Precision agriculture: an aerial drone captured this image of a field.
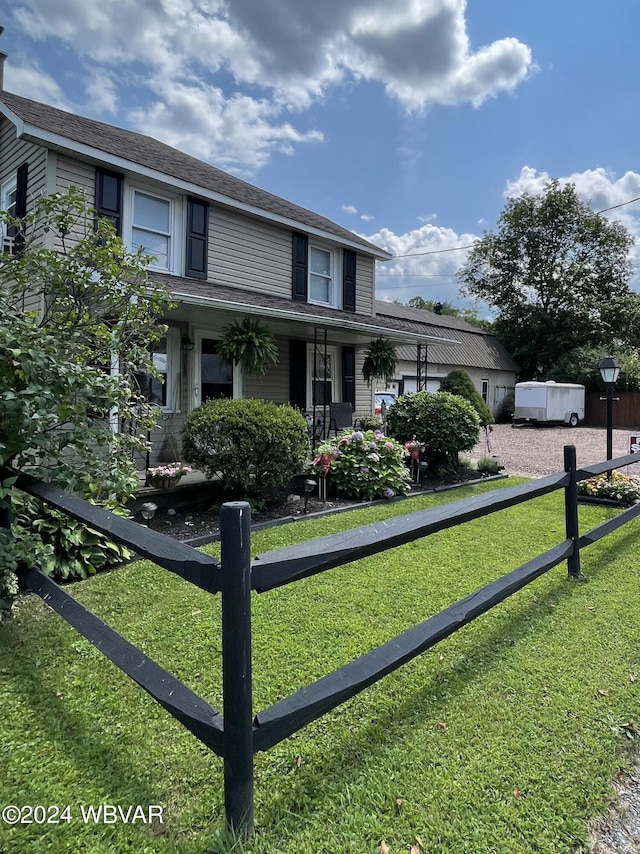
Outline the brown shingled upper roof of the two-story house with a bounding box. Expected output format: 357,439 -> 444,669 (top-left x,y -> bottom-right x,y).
0,92 -> 390,259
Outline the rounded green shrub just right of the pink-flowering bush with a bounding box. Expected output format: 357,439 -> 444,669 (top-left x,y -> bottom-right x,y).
387,391 -> 480,477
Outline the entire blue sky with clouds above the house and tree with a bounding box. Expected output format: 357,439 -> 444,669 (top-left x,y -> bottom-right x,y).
0,0 -> 640,314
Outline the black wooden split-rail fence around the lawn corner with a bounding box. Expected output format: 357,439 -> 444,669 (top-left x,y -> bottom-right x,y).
0,446 -> 640,835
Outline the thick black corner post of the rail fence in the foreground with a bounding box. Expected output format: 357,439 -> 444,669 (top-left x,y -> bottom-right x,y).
220,501 -> 253,838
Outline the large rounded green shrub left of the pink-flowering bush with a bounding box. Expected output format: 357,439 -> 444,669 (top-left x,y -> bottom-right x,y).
182,398 -> 310,498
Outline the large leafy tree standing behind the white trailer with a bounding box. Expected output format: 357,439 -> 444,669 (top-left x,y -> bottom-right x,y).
459,181 -> 637,379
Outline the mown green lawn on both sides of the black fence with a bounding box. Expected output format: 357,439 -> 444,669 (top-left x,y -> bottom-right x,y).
0,478 -> 640,854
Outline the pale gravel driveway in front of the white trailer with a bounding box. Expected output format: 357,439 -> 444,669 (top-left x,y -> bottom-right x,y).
463,424 -> 640,477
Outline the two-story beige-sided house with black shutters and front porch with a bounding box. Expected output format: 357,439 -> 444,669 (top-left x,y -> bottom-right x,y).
0,75 -> 458,459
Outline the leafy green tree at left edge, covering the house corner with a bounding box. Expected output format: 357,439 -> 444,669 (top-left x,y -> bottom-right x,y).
0,189 -> 170,596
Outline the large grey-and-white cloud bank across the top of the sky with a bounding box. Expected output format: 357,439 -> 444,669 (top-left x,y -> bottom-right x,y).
11,0 -> 533,168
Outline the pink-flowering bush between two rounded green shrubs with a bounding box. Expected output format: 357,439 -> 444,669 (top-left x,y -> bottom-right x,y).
312,429 -> 411,500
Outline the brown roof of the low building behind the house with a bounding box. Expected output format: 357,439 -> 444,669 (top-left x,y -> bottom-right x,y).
376,300 -> 520,372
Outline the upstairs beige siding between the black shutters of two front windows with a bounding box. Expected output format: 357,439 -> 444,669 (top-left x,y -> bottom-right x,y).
208,205 -> 291,297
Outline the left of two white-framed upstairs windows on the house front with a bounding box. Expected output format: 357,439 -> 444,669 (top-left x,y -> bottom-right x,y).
131,189 -> 177,270
